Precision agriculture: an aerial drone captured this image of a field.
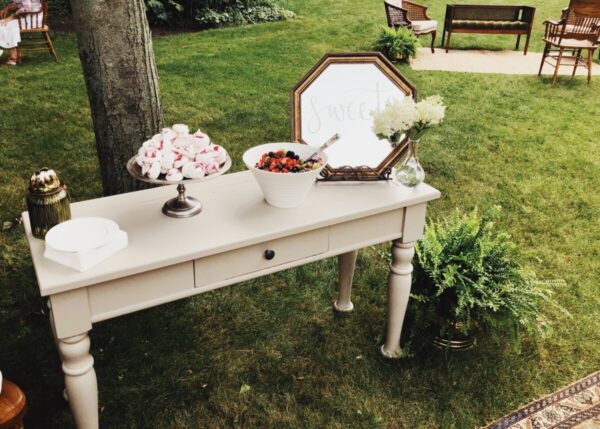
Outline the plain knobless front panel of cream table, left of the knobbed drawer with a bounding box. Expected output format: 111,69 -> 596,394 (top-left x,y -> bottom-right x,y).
88,261 -> 194,322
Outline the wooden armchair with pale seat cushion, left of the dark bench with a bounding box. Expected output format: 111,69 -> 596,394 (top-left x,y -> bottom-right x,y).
383,0 -> 437,53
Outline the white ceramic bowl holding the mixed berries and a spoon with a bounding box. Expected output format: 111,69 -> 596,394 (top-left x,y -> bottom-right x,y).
244,143 -> 327,209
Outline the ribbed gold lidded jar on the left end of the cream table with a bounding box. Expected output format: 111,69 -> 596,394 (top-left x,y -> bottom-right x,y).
27,167 -> 71,239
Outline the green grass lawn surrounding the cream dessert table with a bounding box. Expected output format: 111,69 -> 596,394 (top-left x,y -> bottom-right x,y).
0,0 -> 600,428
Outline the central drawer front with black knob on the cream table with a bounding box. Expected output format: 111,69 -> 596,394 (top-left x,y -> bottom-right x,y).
194,228 -> 329,287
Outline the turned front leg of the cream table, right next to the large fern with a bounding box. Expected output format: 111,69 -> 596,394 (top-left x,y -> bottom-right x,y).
381,240 -> 415,359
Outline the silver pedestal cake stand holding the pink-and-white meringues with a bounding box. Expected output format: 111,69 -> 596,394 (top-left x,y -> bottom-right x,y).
127,154 -> 231,218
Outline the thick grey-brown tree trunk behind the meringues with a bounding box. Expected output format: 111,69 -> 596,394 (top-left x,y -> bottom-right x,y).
71,0 -> 163,195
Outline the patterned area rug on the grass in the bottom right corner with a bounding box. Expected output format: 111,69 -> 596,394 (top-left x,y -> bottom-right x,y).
484,371 -> 600,429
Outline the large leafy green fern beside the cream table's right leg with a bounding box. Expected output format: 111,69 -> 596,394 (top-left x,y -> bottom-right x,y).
400,207 -> 565,353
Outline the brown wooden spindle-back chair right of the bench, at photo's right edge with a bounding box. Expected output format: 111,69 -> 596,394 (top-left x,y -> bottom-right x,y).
538,0 -> 600,84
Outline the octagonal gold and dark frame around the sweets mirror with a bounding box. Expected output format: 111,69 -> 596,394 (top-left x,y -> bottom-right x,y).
292,52 -> 417,181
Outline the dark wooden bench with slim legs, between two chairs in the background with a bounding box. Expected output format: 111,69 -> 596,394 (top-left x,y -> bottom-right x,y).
442,4 -> 535,55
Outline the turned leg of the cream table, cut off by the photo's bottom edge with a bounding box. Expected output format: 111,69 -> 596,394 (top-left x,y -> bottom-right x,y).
58,332 -> 99,429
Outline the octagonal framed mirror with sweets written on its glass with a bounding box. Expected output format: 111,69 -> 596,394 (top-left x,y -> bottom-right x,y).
292,52 -> 416,180
